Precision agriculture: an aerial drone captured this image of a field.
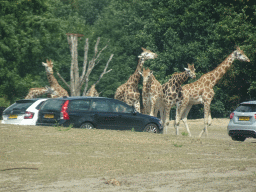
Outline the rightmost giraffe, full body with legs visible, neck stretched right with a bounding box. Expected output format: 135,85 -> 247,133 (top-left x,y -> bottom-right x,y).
174,47 -> 250,138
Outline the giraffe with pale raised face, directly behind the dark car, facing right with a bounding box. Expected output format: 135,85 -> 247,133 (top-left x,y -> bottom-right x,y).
114,47 -> 157,112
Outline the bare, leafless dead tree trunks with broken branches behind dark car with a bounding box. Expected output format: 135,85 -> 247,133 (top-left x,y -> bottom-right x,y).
58,33 -> 114,96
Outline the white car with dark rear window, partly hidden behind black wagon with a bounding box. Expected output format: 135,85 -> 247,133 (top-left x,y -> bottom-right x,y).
2,98 -> 47,125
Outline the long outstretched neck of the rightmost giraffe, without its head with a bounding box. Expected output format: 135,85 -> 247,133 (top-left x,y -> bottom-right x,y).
200,52 -> 235,87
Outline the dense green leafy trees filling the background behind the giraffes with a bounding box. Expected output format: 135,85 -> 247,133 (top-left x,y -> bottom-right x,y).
0,0 -> 256,118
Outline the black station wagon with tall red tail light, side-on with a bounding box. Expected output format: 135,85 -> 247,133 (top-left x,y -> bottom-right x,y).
36,97 -> 163,133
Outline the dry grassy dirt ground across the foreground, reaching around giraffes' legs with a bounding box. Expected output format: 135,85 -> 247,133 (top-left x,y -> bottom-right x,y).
0,119 -> 256,192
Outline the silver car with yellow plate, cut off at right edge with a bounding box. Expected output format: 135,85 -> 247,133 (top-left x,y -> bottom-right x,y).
228,101 -> 256,141
